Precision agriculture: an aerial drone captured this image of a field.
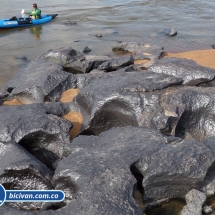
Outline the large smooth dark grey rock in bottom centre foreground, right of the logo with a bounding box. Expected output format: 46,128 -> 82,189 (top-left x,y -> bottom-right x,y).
49,127 -> 165,215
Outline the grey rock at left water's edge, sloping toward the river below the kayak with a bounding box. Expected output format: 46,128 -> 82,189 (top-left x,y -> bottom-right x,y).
4,60 -> 76,104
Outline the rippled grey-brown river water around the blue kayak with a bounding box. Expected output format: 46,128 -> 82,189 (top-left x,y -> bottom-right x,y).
0,0 -> 215,85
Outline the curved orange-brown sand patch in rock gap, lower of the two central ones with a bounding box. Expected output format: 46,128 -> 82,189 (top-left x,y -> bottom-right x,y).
63,111 -> 83,138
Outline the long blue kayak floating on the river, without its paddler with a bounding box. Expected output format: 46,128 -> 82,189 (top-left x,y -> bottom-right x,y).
0,14 -> 58,28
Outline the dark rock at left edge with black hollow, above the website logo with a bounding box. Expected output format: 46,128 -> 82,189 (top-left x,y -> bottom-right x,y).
0,104 -> 72,169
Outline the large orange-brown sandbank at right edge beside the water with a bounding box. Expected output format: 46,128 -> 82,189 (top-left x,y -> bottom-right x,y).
163,49 -> 215,69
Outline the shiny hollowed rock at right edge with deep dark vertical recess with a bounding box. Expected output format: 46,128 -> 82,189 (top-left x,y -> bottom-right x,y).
160,87 -> 215,141
